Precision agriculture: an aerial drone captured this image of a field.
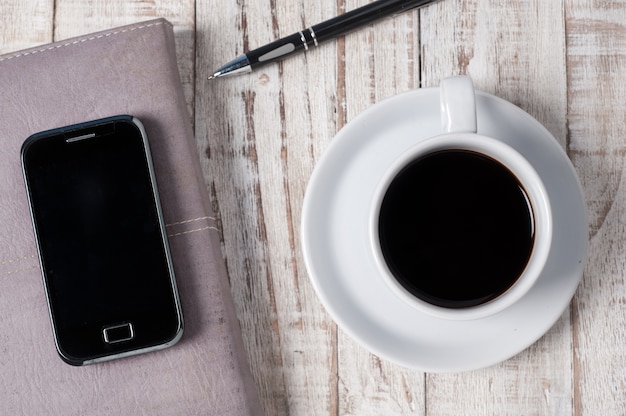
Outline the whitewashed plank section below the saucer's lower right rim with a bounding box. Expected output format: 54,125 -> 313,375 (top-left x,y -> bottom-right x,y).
426,314 -> 572,416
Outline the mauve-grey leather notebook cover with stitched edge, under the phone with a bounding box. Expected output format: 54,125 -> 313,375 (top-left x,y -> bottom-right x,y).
0,19 -> 262,416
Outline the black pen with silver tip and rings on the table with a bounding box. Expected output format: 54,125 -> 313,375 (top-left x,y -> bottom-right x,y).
209,0 -> 436,79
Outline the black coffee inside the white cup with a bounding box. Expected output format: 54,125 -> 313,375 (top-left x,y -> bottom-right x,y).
378,150 -> 534,308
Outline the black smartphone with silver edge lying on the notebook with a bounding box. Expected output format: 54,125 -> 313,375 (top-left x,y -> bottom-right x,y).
21,115 -> 183,365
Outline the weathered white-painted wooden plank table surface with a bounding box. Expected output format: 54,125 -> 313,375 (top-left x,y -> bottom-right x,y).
0,0 -> 626,416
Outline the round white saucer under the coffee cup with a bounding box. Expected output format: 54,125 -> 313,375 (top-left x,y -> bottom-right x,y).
302,88 -> 588,372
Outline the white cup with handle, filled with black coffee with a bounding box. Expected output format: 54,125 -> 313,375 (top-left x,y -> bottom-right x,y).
369,77 -> 553,320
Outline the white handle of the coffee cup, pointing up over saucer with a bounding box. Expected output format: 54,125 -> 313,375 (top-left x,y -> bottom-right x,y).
439,76 -> 477,133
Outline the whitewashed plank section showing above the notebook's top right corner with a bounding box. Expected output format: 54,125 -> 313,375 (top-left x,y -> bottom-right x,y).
54,0 -> 195,117
